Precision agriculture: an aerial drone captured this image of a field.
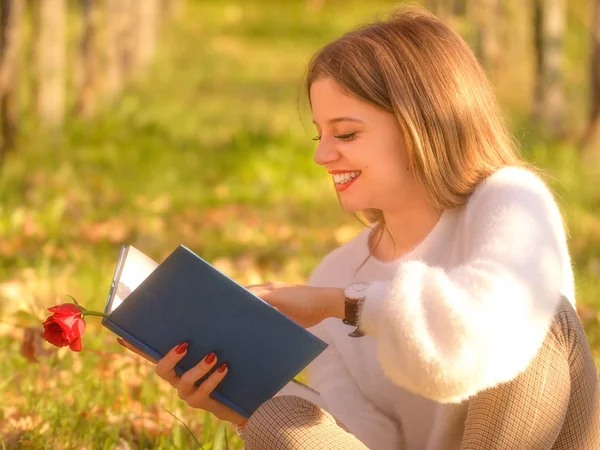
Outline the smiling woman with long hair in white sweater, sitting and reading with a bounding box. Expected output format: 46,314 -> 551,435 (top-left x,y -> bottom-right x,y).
118,8 -> 600,449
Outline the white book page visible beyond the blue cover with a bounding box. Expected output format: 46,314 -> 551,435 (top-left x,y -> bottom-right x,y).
108,245 -> 158,313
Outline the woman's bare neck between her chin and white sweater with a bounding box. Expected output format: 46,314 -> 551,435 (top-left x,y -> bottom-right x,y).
371,204 -> 441,261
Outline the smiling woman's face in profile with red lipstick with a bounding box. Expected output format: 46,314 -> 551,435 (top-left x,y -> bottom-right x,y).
310,78 -> 423,213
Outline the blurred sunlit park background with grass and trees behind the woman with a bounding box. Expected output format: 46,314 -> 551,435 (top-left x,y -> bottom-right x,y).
0,0 -> 600,449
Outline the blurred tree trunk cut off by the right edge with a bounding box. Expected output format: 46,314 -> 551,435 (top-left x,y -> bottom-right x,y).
582,0 -> 600,152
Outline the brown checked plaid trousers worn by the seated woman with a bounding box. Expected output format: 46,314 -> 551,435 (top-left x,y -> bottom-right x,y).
244,298 -> 600,450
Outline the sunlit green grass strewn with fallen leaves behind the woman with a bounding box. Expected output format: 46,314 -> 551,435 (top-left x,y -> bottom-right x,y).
0,0 -> 600,449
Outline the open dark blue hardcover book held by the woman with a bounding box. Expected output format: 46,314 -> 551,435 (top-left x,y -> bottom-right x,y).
102,245 -> 327,417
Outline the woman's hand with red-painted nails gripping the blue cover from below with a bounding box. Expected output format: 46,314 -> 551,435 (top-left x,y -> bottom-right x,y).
117,338 -> 247,426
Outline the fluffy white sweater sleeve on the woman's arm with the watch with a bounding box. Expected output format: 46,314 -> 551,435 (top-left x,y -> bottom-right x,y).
360,169 -> 574,403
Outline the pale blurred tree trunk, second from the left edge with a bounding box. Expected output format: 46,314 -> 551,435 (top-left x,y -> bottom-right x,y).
34,0 -> 67,126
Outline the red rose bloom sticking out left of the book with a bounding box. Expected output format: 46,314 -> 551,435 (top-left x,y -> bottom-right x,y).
43,303 -> 85,352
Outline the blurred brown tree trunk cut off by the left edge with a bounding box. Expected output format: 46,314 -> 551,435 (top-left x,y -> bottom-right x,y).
0,0 -> 24,158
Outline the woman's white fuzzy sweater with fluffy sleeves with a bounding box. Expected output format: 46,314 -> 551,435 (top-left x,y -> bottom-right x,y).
282,167 -> 575,450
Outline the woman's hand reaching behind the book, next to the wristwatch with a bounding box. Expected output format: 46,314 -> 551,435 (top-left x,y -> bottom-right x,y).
246,281 -> 344,328
